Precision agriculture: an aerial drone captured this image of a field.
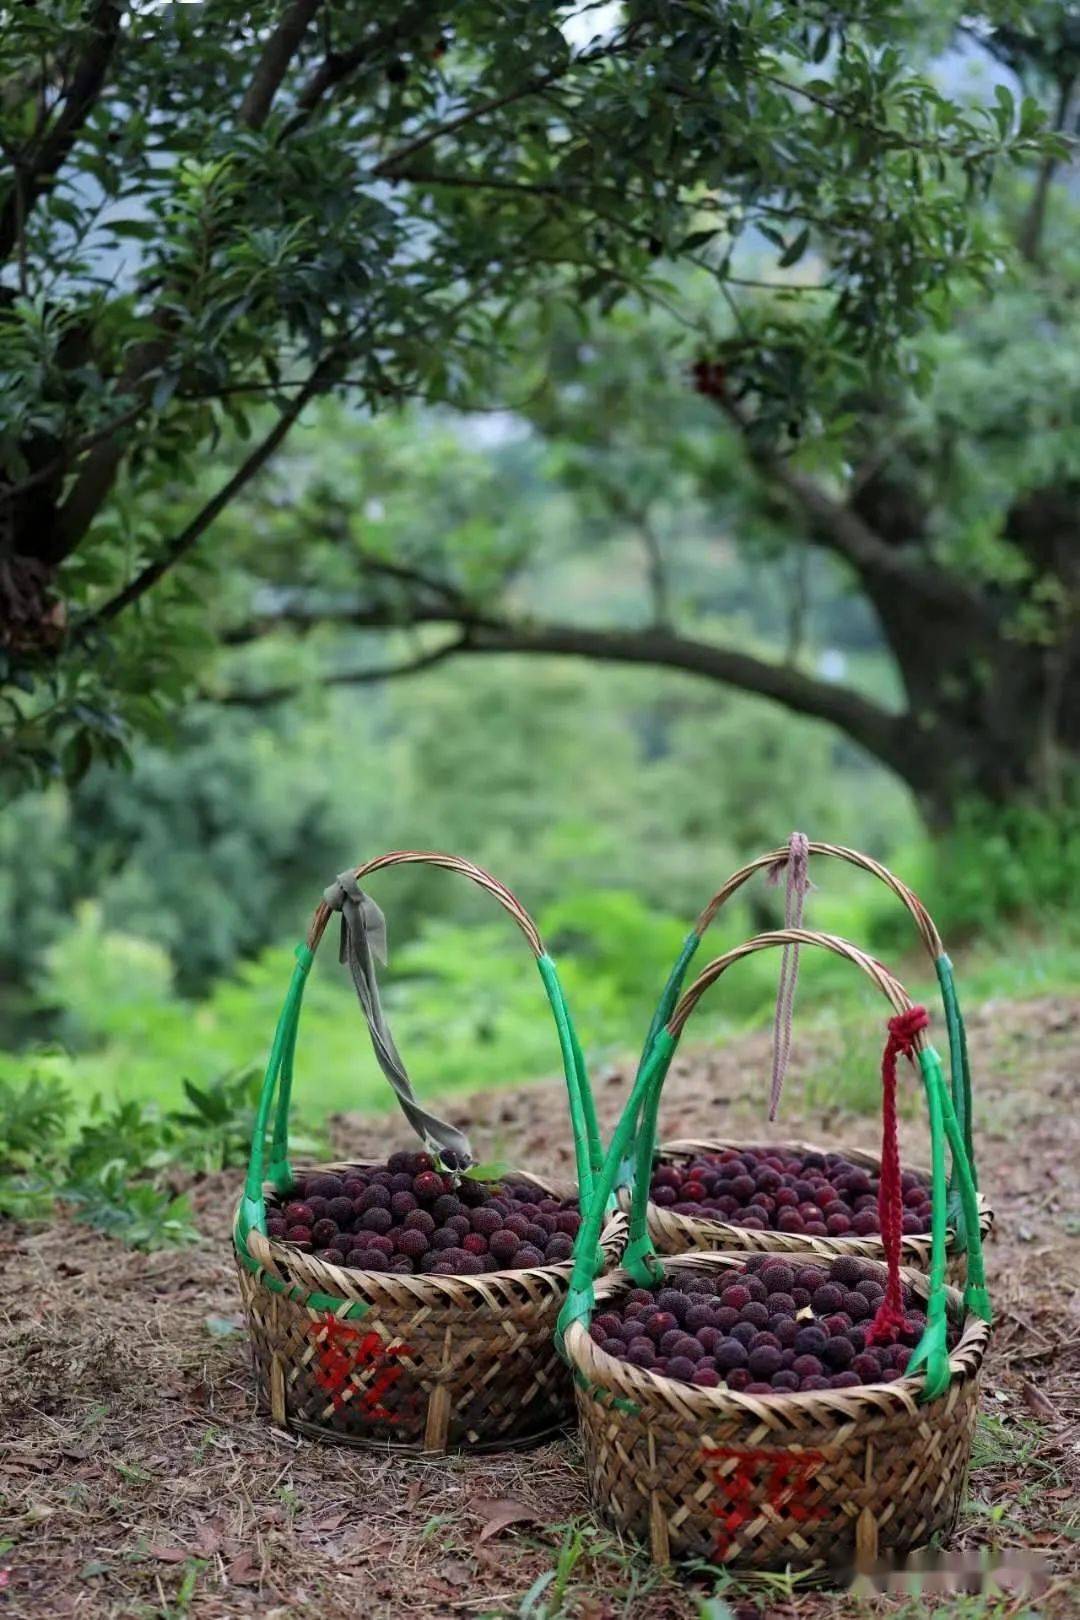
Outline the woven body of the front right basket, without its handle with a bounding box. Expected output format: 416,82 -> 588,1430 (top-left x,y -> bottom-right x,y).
565,1254 -> 989,1571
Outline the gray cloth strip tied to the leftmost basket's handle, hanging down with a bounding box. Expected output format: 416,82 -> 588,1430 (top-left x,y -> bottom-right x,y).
322,872 -> 474,1170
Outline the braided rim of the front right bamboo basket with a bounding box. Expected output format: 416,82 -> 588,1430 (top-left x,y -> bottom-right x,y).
565,1249 -> 991,1439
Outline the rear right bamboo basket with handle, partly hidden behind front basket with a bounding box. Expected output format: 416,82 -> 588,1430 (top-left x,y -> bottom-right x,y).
619,842 -> 994,1285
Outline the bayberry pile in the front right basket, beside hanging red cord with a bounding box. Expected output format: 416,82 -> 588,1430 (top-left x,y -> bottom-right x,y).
589,1254 -> 945,1395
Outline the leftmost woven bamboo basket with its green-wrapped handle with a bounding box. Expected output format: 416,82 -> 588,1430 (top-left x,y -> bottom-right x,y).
233,851 -> 625,1452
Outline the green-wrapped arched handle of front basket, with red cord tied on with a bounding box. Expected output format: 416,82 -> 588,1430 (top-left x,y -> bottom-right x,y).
559,928 -> 989,1396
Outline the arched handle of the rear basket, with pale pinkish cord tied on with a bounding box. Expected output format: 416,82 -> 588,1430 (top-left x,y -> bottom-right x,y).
641,842 -> 978,1224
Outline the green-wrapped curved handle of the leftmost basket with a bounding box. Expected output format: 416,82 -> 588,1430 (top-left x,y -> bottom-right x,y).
240,849 -> 602,1236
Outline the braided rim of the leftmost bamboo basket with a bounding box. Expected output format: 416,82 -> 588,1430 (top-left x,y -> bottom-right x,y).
232,1158 -> 627,1306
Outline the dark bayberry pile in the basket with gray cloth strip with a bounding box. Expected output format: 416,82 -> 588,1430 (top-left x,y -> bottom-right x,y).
266,1153 -> 581,1277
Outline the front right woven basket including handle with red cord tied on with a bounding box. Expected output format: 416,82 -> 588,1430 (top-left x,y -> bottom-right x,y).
559,928 -> 989,1573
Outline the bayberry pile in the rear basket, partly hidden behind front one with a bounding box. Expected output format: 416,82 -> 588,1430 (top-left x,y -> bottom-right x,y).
649,1147 -> 929,1238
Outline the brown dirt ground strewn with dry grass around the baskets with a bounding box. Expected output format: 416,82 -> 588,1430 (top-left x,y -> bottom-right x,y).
0,1000 -> 1080,1620
